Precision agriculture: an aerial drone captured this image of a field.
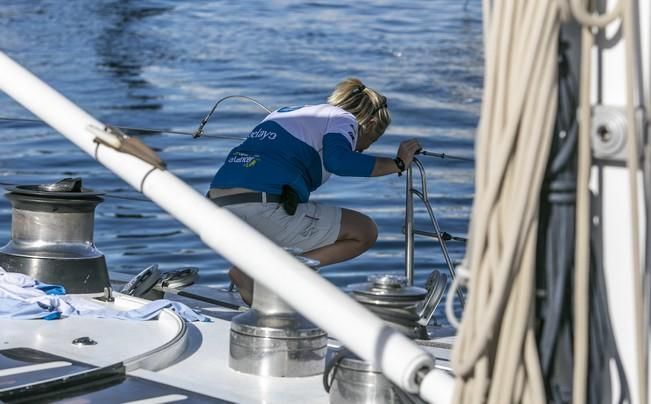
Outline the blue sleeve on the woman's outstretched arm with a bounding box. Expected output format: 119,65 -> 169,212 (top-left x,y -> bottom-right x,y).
323,133 -> 375,177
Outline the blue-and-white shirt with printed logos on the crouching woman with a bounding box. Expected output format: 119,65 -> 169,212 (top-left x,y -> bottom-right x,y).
210,104 -> 375,202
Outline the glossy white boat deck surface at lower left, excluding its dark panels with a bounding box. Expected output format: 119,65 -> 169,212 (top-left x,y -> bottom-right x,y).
0,294 -> 452,404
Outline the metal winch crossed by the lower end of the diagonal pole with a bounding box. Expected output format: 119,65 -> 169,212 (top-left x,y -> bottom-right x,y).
324,271 -> 447,404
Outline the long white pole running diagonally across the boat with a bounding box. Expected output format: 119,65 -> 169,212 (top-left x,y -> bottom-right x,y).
0,52 -> 449,403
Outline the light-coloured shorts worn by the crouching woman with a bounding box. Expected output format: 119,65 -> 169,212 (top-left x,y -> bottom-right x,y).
224,202 -> 341,251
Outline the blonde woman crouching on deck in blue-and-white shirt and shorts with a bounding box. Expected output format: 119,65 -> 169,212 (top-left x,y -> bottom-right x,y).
208,78 -> 421,305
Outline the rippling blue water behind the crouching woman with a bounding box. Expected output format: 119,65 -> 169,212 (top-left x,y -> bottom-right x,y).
0,0 -> 483,300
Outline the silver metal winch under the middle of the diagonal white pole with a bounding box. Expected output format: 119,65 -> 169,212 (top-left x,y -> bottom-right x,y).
229,257 -> 328,377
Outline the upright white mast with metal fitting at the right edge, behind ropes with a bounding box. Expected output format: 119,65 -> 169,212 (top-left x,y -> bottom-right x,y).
591,0 -> 651,403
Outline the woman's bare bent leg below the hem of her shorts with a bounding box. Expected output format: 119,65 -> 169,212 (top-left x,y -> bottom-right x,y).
303,208 -> 377,266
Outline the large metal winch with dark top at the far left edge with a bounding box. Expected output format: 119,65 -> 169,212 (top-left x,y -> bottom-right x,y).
0,178 -> 110,293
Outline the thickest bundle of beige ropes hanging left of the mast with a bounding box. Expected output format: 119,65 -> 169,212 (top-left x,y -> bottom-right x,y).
452,0 -> 560,404
